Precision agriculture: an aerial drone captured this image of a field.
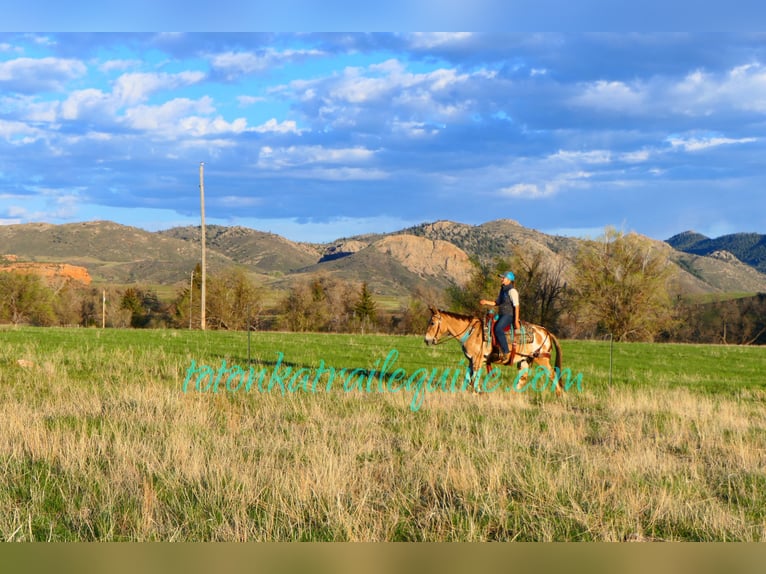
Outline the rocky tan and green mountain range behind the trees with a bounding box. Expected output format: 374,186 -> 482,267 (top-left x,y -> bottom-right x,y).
0,219 -> 766,299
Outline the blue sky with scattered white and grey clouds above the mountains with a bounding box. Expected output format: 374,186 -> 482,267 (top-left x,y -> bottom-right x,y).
0,31 -> 766,242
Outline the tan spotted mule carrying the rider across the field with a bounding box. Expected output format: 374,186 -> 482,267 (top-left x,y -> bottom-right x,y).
424,307 -> 561,395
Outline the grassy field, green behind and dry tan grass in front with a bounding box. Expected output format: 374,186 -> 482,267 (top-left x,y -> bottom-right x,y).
0,328 -> 766,541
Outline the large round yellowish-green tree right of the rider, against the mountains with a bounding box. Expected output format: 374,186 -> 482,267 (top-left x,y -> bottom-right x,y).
571,228 -> 673,341
